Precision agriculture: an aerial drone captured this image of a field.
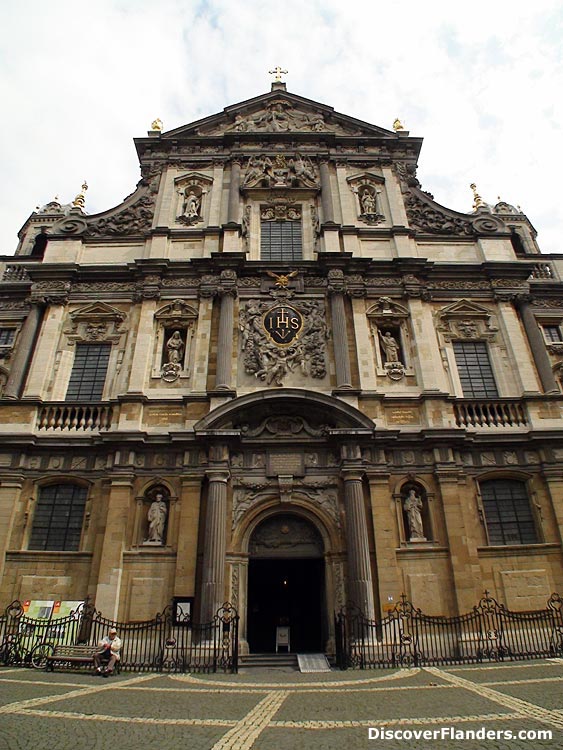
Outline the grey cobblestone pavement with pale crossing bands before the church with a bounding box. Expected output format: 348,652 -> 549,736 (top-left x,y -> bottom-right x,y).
0,659 -> 563,750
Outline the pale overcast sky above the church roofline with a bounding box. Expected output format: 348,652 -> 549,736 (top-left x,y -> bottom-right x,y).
0,0 -> 563,255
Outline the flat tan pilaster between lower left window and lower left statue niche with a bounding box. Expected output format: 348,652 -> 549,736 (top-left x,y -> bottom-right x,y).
95,474 -> 133,620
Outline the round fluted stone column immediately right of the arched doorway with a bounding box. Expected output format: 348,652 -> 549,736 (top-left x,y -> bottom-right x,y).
342,469 -> 375,619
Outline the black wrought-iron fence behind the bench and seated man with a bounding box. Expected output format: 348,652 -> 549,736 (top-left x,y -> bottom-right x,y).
0,600 -> 239,672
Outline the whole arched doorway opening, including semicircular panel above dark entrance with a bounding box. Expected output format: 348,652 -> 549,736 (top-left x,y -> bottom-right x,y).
247,513 -> 326,653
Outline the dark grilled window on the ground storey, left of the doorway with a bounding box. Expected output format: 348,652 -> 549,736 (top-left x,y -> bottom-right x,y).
29,484 -> 87,552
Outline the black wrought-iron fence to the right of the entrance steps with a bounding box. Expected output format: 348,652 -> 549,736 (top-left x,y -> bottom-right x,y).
335,592 -> 563,669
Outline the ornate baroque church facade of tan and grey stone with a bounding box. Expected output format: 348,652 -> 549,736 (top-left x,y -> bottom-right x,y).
0,80 -> 563,652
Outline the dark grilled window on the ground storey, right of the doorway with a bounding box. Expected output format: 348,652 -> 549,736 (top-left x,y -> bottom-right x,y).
481,479 -> 538,544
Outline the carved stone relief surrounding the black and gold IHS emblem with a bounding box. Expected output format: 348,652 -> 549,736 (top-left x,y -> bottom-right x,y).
239,300 -> 328,386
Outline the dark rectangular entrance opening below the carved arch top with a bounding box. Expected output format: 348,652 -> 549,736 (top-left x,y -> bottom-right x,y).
248,558 -> 324,653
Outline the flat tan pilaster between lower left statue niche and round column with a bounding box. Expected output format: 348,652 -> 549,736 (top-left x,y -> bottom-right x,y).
174,474 -> 205,596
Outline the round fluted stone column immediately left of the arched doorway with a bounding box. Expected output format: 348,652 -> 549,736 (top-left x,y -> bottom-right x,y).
199,469 -> 229,623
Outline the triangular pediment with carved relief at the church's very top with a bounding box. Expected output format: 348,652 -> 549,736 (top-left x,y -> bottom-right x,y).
158,90 -> 398,140
